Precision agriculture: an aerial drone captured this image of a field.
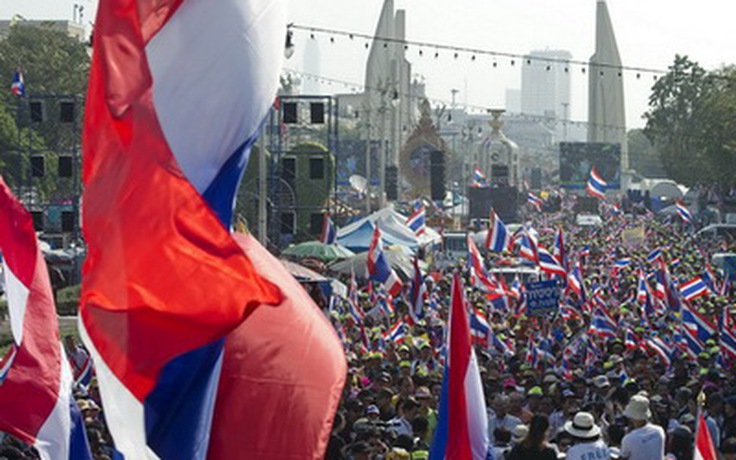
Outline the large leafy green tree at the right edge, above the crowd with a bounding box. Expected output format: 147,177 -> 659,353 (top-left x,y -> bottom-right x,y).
644,56 -> 736,192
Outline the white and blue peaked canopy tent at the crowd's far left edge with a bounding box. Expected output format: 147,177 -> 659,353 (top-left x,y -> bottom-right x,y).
337,208 -> 442,252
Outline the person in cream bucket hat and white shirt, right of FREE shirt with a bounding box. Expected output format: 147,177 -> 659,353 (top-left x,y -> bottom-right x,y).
621,394 -> 665,460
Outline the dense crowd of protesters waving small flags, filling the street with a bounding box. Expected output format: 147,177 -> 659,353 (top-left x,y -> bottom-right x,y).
0,192 -> 736,460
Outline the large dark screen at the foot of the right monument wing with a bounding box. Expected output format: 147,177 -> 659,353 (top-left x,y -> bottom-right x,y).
560,142 -> 621,189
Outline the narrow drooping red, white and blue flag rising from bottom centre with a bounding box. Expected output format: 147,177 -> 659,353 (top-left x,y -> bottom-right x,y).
429,273 -> 491,460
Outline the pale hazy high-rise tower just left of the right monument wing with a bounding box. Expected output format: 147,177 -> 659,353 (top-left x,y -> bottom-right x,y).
521,50 -> 572,119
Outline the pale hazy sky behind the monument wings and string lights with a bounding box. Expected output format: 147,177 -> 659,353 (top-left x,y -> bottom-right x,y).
0,0 -> 736,127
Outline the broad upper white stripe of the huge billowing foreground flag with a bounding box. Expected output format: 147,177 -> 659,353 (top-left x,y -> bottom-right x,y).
146,0 -> 286,193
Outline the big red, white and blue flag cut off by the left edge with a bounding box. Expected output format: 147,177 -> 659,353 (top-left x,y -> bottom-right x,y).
0,178 -> 92,460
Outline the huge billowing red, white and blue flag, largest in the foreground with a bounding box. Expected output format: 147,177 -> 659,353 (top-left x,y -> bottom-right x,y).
80,0 -> 346,459
